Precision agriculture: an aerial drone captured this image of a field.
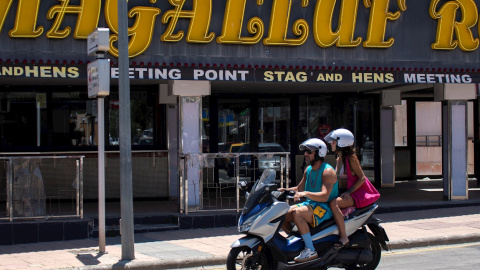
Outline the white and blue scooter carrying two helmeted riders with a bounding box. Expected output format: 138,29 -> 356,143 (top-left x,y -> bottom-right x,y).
227,169 -> 389,270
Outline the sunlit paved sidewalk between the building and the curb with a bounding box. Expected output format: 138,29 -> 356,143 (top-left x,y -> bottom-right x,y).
0,206 -> 480,270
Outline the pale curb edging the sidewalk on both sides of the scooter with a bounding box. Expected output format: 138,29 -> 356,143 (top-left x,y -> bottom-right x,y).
70,233 -> 480,270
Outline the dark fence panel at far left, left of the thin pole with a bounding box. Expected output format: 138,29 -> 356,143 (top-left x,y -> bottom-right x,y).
0,156 -> 84,221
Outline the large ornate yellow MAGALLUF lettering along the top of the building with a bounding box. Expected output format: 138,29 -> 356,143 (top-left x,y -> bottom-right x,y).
0,0 -> 480,57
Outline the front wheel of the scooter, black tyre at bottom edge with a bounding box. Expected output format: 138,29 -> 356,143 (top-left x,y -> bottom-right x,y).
227,246 -> 271,270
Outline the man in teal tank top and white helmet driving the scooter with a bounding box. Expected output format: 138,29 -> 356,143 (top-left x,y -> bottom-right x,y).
279,138 -> 338,262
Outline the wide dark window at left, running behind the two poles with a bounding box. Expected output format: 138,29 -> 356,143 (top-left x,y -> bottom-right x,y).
0,86 -> 158,151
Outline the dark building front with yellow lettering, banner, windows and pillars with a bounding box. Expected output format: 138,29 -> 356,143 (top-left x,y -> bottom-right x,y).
0,0 -> 480,210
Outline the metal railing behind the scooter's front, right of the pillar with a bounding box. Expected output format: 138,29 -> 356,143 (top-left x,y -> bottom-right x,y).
179,152 -> 290,214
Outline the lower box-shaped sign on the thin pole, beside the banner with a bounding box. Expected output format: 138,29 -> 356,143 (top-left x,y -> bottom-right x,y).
87,59 -> 110,98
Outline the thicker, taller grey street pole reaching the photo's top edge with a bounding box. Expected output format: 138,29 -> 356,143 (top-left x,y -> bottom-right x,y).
118,0 -> 135,260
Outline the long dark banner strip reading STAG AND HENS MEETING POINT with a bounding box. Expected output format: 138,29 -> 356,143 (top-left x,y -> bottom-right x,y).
0,62 -> 480,84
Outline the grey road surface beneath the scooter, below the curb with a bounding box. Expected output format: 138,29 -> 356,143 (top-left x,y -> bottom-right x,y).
182,242 -> 480,270
